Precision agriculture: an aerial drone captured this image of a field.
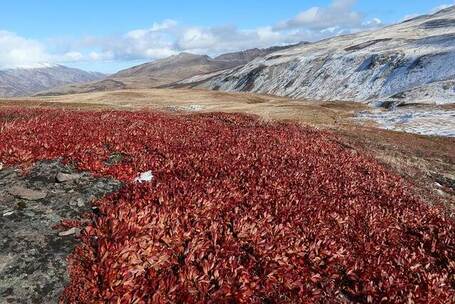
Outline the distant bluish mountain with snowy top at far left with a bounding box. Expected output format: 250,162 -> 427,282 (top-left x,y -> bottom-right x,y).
0,65 -> 105,97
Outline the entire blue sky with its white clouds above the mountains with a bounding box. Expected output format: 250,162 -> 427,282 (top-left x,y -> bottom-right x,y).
0,0 -> 453,73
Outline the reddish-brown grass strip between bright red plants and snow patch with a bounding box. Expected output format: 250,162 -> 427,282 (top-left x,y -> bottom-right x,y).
336,124 -> 455,212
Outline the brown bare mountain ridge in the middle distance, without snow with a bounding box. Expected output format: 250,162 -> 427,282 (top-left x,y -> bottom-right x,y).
39,46 -> 302,95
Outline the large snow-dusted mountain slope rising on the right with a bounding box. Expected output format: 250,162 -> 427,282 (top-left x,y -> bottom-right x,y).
188,7 -> 455,104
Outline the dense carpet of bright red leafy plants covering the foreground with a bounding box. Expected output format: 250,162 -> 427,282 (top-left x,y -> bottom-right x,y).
0,108 -> 455,303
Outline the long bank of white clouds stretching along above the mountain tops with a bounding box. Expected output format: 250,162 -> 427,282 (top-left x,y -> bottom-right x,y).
0,0 -> 390,68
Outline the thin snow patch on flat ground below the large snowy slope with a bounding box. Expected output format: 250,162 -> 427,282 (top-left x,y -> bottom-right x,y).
357,108 -> 455,137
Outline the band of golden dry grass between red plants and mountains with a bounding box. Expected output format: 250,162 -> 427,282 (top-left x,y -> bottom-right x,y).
0,89 -> 365,125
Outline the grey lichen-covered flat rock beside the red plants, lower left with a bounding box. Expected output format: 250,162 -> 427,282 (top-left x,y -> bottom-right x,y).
0,161 -> 121,304
